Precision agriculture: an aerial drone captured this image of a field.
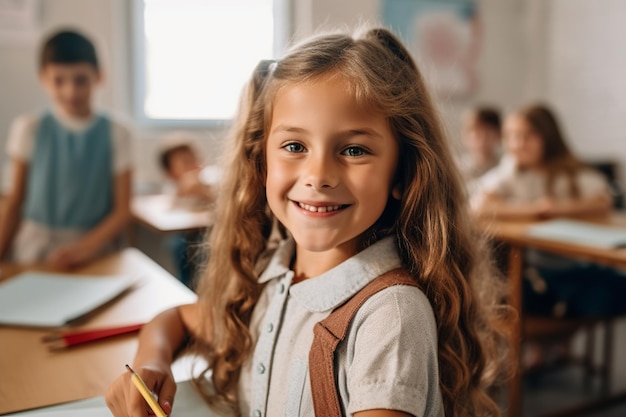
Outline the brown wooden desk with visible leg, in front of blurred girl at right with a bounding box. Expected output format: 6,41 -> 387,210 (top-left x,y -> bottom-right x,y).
481,212 -> 626,417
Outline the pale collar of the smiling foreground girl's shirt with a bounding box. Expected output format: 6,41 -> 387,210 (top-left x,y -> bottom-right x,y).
259,237 -> 401,312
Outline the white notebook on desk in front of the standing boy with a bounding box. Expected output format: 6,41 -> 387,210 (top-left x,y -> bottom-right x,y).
0,272 -> 136,327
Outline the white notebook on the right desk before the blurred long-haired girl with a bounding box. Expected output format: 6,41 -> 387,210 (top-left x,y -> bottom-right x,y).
526,219 -> 626,249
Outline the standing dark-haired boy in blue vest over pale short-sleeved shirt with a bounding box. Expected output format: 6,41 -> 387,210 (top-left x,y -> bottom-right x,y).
0,30 -> 131,268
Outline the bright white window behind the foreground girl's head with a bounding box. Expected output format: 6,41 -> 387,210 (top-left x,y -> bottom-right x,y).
134,0 -> 288,124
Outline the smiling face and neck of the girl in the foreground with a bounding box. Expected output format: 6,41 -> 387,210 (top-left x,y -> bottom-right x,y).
266,76 -> 399,276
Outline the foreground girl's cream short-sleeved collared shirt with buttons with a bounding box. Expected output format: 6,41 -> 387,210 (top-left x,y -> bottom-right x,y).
239,238 -> 443,417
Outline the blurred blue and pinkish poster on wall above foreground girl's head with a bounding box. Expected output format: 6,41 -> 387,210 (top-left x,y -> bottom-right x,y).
381,0 -> 481,98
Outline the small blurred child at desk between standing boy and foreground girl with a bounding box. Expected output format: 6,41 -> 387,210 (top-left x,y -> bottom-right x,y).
159,132 -> 219,288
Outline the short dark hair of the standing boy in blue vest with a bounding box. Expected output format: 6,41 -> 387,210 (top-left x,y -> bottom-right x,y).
39,30 -> 100,71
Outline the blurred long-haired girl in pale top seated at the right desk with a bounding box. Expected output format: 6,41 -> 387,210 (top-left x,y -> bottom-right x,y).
475,105 -> 626,360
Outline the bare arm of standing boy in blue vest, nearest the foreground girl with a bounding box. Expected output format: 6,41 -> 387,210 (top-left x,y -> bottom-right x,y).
48,170 -> 131,268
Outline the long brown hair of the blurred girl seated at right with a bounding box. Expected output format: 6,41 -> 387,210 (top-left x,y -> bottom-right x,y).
518,104 -> 584,198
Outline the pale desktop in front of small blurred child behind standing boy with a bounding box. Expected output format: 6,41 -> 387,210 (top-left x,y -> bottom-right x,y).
131,194 -> 213,233
